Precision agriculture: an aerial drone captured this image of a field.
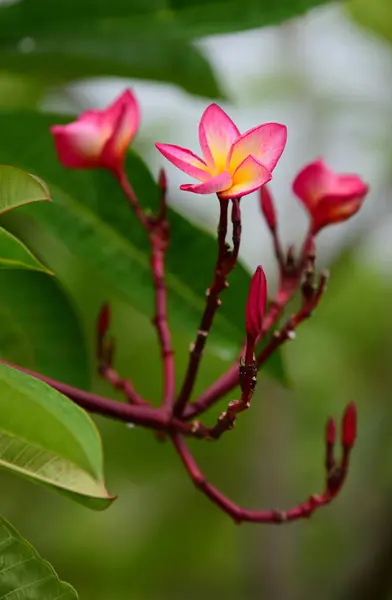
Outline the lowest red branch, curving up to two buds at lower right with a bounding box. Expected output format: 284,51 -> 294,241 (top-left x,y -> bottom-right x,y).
172,404 -> 356,524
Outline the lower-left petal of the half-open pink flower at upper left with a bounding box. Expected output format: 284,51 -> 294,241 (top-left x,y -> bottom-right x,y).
50,118 -> 105,168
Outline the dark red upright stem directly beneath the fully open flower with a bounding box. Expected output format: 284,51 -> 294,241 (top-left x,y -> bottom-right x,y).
175,198 -> 241,416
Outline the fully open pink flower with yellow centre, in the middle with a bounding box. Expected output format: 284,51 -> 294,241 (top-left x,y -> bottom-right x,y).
156,104 -> 287,198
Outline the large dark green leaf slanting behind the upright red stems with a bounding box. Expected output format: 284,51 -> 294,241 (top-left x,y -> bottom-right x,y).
0,113 -> 286,386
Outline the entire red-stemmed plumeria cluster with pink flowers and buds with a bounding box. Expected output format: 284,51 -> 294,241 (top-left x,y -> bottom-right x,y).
43,90 -> 368,523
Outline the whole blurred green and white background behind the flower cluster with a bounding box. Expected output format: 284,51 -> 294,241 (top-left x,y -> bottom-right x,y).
0,0 -> 392,600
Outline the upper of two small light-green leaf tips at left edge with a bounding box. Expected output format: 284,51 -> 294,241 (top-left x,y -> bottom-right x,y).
0,165 -> 50,214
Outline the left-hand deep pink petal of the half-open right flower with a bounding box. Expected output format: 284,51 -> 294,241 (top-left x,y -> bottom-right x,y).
293,158 -> 336,211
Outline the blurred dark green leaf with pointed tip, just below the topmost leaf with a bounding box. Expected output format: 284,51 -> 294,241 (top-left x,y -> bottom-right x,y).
0,28 -> 222,98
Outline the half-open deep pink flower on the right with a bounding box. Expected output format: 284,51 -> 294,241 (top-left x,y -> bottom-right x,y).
293,159 -> 369,235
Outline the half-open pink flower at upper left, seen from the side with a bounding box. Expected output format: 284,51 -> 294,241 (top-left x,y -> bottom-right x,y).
50,90 -> 140,172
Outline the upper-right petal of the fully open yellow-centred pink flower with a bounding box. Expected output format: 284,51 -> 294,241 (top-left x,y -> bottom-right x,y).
229,123 -> 287,173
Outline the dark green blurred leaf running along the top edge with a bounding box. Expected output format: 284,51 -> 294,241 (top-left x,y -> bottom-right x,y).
0,0 -> 334,40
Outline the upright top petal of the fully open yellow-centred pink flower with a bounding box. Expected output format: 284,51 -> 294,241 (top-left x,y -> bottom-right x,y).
199,104 -> 240,174
